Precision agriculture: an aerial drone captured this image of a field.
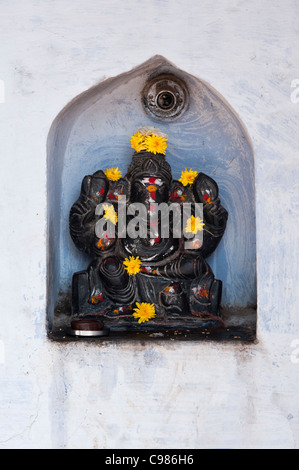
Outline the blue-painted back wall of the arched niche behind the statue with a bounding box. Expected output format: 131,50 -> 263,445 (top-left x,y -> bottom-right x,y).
47,56 -> 257,331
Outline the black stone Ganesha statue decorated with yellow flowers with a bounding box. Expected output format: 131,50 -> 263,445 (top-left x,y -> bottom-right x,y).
69,127 -> 228,329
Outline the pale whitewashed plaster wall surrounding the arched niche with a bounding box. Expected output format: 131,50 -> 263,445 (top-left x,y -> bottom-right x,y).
0,0 -> 299,448
